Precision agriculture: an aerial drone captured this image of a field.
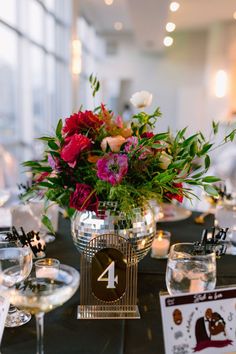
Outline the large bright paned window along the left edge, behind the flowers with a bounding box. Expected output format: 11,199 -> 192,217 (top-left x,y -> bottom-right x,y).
0,0 -> 72,178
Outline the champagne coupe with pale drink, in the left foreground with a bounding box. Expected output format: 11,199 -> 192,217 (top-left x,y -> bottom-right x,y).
9,264 -> 80,354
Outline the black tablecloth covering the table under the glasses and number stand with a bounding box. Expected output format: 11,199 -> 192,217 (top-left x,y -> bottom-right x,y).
1,213 -> 236,354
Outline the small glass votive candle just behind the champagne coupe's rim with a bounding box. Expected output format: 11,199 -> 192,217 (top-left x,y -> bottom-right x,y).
34,258 -> 60,279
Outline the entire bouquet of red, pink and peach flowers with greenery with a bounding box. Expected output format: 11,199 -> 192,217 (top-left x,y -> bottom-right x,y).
23,76 -> 235,236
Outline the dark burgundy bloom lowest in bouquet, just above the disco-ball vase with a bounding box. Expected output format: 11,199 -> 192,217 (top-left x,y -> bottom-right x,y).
70,183 -> 98,213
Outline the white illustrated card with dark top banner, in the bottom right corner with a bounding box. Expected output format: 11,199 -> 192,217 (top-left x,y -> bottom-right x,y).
160,285 -> 236,354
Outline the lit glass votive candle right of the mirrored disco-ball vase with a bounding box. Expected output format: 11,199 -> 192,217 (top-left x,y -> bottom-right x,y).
151,230 -> 171,258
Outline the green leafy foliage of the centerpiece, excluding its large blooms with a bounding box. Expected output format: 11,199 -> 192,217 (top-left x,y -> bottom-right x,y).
19,75 -> 236,232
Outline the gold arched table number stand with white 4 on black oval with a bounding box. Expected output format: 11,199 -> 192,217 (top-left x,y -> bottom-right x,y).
77,234 -> 140,319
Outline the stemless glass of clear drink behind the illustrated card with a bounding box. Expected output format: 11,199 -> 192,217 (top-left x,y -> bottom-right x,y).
166,243 -> 216,295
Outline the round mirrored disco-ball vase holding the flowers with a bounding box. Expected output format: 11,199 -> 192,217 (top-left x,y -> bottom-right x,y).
71,203 -> 156,261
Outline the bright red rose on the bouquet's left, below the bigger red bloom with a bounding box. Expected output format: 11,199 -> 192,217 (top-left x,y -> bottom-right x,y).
61,134 -> 91,167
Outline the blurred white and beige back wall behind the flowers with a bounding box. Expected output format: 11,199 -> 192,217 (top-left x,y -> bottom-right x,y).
99,24 -> 236,136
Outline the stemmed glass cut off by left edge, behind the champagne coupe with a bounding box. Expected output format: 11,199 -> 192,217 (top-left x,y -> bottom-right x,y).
0,232 -> 32,327
